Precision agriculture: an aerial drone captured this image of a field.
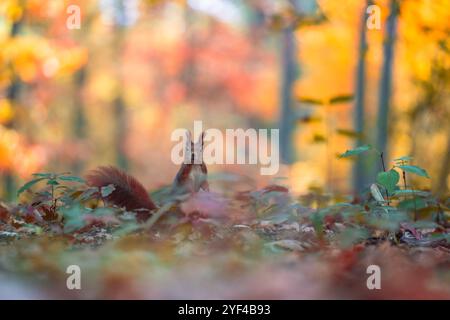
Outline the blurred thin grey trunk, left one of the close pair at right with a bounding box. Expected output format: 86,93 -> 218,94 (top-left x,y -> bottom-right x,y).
353,0 -> 373,195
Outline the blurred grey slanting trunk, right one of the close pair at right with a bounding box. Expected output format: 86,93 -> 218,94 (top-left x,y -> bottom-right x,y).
377,0 -> 399,168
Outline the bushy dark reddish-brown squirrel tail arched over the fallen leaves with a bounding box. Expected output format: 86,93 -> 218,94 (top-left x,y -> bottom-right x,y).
86,166 -> 156,219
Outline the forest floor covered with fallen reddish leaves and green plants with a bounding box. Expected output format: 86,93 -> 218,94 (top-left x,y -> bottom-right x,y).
0,166 -> 450,299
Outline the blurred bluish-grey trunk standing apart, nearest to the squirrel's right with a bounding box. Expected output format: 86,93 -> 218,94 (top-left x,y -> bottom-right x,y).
280,26 -> 296,164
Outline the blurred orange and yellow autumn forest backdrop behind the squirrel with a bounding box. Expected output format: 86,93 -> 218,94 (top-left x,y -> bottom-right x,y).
0,0 -> 450,200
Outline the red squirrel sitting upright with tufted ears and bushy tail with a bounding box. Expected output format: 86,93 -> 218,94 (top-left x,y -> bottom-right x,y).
86,131 -> 209,220
